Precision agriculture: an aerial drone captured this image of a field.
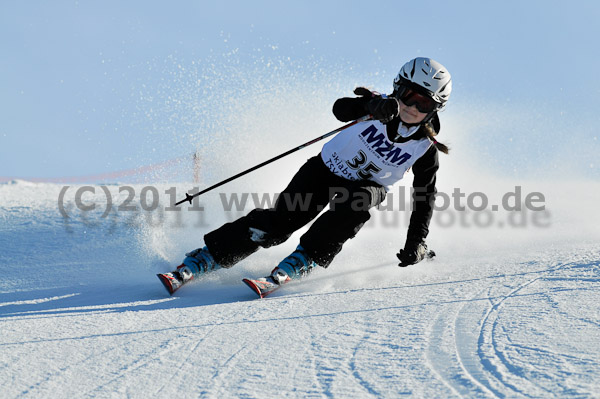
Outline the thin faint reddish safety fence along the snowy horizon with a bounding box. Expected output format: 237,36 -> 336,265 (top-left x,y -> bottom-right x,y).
0,153 -> 200,184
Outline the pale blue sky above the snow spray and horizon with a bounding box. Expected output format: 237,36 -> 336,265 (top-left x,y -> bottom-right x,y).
0,1 -> 600,177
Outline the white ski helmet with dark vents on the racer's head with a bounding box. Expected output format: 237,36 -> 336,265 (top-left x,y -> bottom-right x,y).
394,57 -> 452,108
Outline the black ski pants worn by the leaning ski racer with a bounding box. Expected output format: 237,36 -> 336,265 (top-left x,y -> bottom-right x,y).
204,155 -> 386,268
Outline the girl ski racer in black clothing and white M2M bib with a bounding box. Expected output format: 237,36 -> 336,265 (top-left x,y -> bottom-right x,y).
158,58 -> 452,293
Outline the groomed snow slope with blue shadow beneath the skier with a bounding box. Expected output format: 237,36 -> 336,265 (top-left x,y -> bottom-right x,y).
0,173 -> 600,398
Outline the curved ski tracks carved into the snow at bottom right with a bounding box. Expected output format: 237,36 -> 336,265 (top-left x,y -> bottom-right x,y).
427,263 -> 598,398
